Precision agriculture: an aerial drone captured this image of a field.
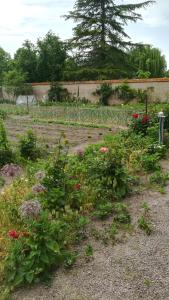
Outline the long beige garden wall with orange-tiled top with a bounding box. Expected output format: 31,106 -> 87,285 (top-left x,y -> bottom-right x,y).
32,78 -> 169,104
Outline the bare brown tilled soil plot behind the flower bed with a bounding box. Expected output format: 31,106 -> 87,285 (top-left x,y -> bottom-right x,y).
5,116 -> 121,148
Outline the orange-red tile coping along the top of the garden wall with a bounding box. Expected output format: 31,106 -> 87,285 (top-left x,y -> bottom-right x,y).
31,77 -> 169,86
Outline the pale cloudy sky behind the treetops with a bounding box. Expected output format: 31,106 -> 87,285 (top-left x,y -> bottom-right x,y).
0,0 -> 169,67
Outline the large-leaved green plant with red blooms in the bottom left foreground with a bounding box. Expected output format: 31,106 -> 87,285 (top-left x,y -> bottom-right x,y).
6,214 -> 74,288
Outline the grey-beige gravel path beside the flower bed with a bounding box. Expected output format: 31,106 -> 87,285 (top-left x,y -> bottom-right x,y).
13,178 -> 169,300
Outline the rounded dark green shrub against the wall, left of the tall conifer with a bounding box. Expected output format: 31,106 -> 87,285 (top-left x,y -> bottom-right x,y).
48,82 -> 69,102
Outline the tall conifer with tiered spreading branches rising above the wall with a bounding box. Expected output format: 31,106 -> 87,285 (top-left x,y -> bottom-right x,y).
65,0 -> 154,68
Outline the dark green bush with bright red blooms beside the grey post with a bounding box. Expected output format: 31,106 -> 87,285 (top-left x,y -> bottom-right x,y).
130,114 -> 151,135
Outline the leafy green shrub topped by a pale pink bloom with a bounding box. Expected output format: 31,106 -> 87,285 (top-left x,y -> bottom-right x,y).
85,145 -> 129,203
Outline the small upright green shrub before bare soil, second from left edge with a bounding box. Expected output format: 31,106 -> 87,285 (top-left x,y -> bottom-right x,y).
19,130 -> 40,161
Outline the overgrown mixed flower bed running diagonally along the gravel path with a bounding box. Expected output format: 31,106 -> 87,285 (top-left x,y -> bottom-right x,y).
0,102 -> 167,293
